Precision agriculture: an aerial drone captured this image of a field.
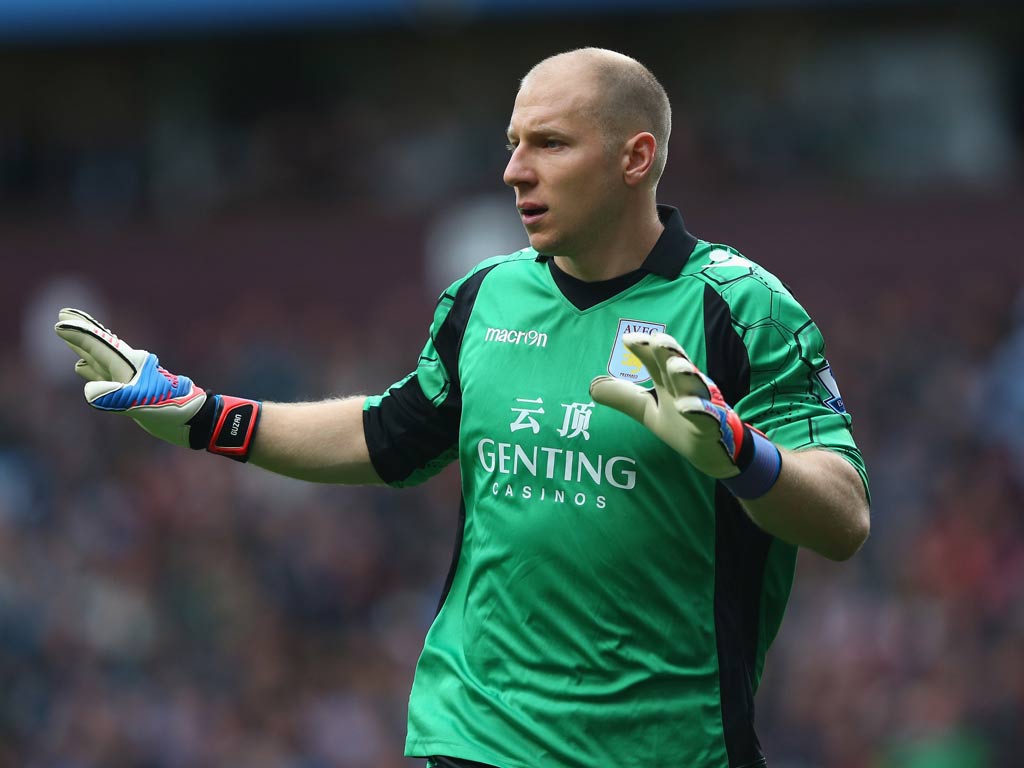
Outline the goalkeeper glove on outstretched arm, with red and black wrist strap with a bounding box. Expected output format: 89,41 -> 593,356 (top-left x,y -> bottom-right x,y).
53,308 -> 262,462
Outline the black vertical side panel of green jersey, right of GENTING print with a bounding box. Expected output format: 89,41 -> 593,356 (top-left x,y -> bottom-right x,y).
705,287 -> 772,768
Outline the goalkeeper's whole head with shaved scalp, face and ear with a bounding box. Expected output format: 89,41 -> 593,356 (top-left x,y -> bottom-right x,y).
505,48 -> 672,256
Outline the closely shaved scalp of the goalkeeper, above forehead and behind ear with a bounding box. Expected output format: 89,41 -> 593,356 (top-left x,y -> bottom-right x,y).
520,48 -> 672,185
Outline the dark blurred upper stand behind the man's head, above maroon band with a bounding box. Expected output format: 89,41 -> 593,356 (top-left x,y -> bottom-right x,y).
0,7 -> 1024,225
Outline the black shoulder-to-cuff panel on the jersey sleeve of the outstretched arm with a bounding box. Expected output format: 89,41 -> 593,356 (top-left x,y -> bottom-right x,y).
362,266 -> 494,483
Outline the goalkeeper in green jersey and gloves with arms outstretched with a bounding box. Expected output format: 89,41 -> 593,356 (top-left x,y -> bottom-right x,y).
56,48 -> 868,768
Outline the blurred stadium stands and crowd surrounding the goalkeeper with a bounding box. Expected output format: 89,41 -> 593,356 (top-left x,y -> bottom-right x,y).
0,0 -> 1024,768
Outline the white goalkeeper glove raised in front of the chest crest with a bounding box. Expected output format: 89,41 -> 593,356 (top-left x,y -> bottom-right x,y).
590,333 -> 782,499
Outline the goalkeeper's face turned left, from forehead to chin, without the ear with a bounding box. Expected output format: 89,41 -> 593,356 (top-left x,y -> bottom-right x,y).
504,70 -> 625,258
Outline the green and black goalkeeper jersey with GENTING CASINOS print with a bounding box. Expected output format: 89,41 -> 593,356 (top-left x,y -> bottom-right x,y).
364,207 -> 866,768
